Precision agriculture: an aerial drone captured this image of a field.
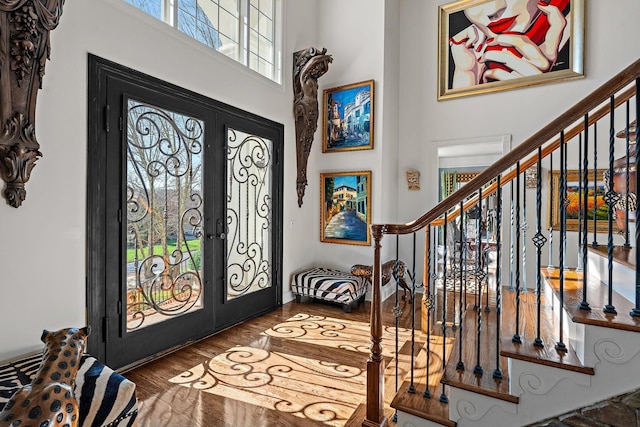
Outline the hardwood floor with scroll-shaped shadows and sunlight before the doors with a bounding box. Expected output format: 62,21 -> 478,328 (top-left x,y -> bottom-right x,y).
125,296 -> 424,427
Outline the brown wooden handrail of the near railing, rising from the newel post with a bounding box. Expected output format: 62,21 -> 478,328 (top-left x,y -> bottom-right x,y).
371,59 -> 640,234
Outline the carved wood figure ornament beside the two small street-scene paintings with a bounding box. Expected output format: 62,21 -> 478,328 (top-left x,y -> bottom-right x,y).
293,47 -> 333,207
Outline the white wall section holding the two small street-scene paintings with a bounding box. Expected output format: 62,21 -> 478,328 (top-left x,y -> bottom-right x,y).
314,0 -> 399,280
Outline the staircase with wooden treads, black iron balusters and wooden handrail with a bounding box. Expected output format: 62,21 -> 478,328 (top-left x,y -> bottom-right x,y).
362,60 -> 640,427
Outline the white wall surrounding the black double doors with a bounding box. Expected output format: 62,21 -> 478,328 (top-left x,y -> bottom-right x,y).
0,0 -> 317,360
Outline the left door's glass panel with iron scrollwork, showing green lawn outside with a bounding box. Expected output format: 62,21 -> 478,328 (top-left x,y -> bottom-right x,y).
125,99 -> 204,332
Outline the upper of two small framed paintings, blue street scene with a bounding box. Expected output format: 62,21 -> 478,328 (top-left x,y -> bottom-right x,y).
322,80 -> 373,153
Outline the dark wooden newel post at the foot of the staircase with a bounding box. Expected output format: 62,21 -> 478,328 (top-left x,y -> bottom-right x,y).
362,225 -> 387,427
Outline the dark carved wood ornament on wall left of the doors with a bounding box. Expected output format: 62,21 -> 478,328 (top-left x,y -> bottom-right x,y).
0,0 -> 64,208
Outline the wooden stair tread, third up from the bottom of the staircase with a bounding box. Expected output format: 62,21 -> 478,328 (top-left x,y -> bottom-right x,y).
500,290 -> 594,375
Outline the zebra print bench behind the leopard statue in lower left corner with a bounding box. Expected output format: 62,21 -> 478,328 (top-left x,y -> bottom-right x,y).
0,353 -> 138,427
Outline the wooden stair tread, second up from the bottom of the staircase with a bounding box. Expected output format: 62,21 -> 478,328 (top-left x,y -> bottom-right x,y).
442,305 -> 518,403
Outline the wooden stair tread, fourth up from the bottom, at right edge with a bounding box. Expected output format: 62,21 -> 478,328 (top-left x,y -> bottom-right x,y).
541,268 -> 640,332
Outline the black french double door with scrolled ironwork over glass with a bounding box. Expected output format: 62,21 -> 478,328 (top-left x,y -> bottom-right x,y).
87,56 -> 282,368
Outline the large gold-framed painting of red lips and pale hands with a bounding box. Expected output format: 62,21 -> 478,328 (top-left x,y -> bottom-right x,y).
438,0 -> 584,100
